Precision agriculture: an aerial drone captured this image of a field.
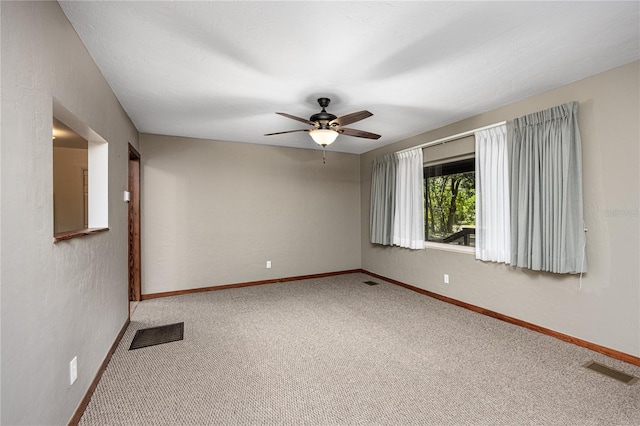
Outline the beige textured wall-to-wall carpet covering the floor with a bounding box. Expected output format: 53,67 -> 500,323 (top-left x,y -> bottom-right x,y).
81,274 -> 640,425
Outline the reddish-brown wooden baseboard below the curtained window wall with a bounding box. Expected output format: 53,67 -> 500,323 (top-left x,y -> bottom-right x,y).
361,270 -> 640,367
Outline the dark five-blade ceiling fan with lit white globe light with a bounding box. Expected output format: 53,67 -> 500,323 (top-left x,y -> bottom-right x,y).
265,98 -> 380,148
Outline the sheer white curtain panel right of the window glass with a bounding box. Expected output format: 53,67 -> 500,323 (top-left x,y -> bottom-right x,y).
475,125 -> 511,263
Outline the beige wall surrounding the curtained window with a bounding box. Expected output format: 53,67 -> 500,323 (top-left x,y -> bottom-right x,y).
361,62 -> 640,356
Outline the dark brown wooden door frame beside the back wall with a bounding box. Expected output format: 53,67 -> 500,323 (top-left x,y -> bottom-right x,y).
127,144 -> 142,315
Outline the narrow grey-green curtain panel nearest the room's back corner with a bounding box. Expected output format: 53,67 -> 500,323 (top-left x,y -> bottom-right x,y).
369,154 -> 397,246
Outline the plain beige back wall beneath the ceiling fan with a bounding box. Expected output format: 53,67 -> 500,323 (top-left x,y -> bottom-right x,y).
140,134 -> 360,294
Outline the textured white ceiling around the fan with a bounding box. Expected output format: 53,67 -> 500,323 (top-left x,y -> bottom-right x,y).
60,1 -> 640,153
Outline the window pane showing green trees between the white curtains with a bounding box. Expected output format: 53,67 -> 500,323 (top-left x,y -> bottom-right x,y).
424,158 -> 476,247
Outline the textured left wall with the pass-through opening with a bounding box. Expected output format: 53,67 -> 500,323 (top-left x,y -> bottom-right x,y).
0,2 -> 138,425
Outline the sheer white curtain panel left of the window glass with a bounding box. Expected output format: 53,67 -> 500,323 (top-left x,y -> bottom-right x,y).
393,148 -> 424,250
